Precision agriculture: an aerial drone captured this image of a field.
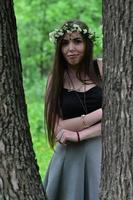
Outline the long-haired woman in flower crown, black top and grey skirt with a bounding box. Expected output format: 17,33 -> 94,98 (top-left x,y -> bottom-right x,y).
44,20 -> 102,200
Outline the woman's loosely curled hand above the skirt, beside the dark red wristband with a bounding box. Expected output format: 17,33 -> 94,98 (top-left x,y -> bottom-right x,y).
56,129 -> 78,144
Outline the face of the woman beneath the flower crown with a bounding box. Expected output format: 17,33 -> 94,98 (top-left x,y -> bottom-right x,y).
61,32 -> 85,66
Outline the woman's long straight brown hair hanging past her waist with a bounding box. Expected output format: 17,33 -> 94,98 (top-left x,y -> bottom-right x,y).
45,20 -> 101,148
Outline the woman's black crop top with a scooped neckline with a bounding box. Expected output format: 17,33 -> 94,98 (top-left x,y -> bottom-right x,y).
61,85 -> 102,119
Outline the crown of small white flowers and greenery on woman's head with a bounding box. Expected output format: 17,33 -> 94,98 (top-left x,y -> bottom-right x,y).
49,23 -> 96,43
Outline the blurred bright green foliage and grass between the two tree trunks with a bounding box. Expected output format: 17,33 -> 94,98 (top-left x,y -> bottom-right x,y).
14,0 -> 102,179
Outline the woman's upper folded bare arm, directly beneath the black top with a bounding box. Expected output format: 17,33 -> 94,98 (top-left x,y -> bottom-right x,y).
55,108 -> 102,132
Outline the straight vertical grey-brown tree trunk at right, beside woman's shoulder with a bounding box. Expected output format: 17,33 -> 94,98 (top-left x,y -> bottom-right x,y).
100,0 -> 133,200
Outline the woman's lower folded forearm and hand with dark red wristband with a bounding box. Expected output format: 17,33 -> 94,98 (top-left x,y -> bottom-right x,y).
56,123 -> 101,144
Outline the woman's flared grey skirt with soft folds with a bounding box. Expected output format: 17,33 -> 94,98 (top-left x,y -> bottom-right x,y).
44,137 -> 101,200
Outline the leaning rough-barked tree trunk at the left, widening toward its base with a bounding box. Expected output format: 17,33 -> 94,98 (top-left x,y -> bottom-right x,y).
0,0 -> 45,200
